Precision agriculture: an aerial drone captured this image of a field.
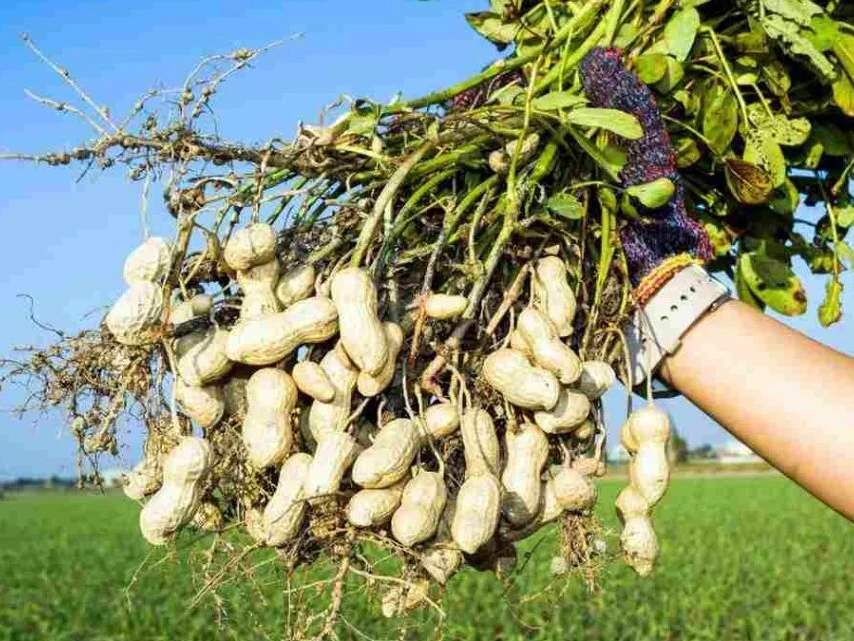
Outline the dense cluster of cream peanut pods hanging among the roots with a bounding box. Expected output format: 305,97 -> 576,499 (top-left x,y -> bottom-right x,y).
106,223 -> 664,584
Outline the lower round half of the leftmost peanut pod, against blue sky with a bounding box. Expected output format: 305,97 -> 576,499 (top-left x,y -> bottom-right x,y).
105,281 -> 163,345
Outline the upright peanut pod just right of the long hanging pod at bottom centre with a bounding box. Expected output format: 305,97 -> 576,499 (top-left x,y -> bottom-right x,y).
501,423 -> 549,527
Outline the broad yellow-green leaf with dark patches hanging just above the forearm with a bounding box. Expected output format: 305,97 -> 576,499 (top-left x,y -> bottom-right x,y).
739,252 -> 807,316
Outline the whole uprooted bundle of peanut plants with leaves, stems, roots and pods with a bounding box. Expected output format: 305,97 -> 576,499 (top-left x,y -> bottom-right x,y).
3,0 -> 854,637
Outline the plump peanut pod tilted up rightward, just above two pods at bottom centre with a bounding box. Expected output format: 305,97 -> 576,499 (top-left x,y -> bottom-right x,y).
353,418 -> 421,488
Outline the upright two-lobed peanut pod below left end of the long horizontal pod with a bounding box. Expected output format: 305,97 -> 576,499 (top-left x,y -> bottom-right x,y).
242,367 -> 297,469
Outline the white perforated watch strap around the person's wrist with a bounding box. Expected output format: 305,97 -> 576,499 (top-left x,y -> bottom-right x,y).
623,265 -> 730,387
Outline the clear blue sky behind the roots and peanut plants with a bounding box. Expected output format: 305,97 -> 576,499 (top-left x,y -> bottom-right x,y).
0,0 -> 854,479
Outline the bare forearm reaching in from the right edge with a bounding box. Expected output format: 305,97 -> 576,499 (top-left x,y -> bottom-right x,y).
661,301 -> 854,520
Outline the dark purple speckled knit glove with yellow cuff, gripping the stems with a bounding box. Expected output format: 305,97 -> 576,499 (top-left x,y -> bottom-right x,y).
581,47 -> 712,305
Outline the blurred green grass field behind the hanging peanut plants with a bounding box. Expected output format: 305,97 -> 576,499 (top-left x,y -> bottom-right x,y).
0,477 -> 854,641
